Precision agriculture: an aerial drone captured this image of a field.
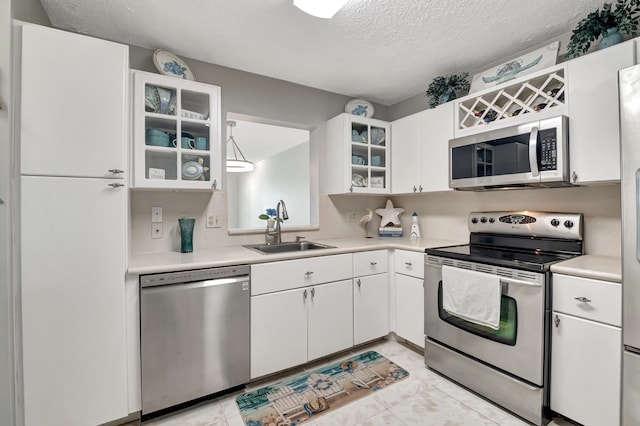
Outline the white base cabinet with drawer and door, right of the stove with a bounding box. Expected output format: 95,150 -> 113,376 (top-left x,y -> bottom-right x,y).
550,274 -> 622,426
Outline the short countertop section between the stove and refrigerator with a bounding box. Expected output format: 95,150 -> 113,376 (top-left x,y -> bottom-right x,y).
551,254 -> 622,283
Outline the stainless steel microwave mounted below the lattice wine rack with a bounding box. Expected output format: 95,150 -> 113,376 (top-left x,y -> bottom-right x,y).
449,116 -> 570,190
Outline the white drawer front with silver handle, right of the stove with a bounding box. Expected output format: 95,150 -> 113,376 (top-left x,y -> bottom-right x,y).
553,274 -> 622,327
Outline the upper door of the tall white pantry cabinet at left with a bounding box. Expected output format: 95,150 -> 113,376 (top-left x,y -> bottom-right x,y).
20,25 -> 129,179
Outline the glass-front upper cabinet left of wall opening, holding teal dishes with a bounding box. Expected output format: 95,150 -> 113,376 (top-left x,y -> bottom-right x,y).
131,71 -> 222,190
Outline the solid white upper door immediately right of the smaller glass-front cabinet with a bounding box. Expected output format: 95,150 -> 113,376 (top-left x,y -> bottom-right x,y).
391,114 -> 421,194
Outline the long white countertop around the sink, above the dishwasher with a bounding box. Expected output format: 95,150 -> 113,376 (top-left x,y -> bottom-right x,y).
128,237 -> 466,275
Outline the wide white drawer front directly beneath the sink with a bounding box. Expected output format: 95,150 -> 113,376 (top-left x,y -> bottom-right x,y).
251,254 -> 353,296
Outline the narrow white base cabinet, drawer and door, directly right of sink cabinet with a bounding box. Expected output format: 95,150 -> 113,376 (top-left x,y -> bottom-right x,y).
353,250 -> 389,345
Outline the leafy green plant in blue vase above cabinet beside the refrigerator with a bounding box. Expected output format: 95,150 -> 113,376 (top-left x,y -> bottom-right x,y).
567,0 -> 640,58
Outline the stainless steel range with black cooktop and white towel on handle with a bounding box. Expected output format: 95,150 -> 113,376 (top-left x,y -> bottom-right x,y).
424,211 -> 583,424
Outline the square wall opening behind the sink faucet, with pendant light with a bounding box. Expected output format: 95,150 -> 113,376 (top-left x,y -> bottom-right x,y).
226,113 -> 318,234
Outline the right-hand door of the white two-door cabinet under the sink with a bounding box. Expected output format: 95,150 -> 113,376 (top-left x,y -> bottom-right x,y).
308,280 -> 353,361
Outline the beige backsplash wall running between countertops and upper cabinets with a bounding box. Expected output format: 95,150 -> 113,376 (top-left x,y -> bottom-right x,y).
131,185 -> 621,256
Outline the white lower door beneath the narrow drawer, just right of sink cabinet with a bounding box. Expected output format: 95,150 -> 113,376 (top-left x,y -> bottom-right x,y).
353,274 -> 389,345
